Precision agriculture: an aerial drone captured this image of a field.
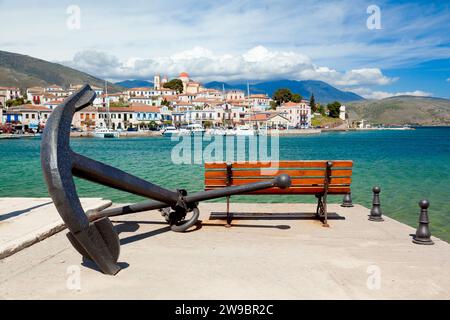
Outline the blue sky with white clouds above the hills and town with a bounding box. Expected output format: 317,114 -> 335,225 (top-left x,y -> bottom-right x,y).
0,0 -> 450,99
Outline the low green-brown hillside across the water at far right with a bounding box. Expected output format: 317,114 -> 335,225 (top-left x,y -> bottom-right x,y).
347,96 -> 450,125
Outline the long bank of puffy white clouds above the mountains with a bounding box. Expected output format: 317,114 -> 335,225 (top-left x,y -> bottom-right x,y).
63,45 -> 396,87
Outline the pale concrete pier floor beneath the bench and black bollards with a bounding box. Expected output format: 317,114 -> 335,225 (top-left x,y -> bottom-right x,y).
0,203 -> 450,299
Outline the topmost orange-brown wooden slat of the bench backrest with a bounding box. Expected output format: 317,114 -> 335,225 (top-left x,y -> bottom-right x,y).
205,160 -> 353,170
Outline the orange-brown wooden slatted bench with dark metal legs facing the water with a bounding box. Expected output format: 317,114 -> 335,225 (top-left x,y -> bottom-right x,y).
205,160 -> 353,226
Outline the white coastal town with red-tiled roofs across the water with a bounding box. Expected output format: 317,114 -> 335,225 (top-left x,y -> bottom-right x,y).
0,72 -> 346,137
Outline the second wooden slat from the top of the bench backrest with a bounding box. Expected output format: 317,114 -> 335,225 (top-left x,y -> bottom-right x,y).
205,169 -> 352,179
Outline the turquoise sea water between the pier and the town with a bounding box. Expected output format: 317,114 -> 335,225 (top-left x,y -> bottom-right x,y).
0,128 -> 450,241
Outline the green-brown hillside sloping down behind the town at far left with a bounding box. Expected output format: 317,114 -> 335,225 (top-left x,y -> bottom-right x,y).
0,51 -> 122,92
